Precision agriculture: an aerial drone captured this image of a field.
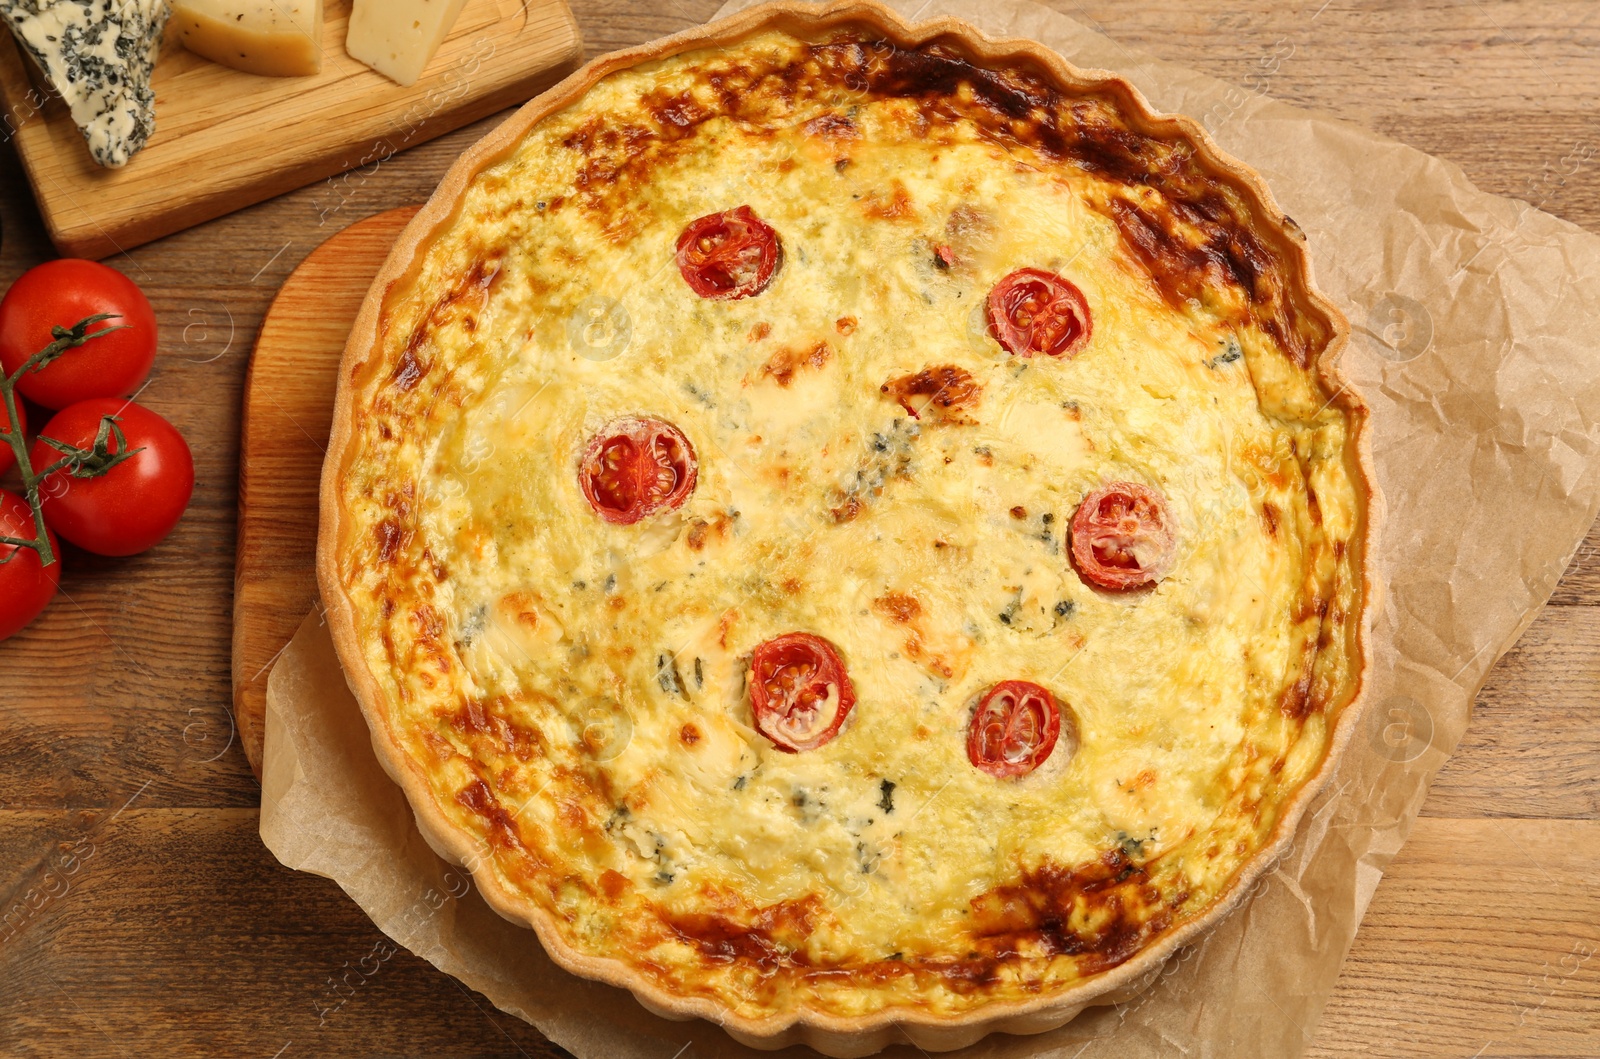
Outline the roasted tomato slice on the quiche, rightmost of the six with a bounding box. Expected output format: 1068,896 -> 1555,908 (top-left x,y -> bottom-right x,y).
1072,482 -> 1178,590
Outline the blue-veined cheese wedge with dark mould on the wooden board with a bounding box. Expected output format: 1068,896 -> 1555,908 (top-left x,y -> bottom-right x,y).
0,0 -> 171,168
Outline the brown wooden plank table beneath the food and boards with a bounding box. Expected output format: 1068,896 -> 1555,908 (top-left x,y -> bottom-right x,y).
0,0 -> 1600,1059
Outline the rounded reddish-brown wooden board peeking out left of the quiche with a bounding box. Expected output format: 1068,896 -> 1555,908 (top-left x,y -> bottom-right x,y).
234,206 -> 418,779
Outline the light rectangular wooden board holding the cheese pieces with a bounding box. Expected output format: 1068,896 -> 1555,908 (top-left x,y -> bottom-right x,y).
0,0 -> 582,259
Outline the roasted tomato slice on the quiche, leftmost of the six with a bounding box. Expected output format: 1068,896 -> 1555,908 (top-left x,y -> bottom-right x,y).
578,416 -> 699,526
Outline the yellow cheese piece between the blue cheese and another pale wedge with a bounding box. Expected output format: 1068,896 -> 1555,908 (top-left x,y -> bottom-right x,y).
173,0 -> 322,77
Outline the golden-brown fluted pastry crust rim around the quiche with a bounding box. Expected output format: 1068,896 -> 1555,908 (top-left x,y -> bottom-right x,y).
317,0 -> 1382,1056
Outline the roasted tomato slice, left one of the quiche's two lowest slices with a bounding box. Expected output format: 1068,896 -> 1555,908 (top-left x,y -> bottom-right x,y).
750,632 -> 856,753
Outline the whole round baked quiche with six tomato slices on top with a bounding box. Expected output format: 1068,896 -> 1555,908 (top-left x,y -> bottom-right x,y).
318,2 -> 1376,1056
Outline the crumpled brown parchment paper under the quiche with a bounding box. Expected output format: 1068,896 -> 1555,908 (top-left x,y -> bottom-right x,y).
252,0 -> 1600,1059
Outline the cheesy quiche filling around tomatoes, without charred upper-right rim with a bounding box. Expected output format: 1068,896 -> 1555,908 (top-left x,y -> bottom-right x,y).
338,34 -> 1365,1016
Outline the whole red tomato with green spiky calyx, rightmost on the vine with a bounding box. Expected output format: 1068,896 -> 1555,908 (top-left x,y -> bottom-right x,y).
32,397 -> 195,555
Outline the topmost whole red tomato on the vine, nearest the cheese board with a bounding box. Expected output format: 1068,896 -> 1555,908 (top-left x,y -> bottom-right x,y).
0,258 -> 155,408
